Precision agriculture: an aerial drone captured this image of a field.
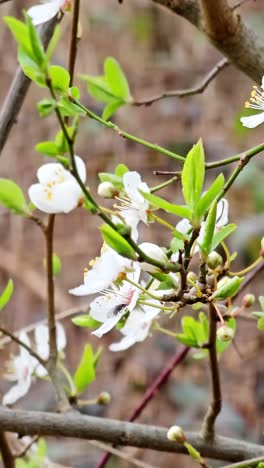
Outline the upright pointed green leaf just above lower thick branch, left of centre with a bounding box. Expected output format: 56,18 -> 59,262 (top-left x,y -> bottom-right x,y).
73,344 -> 95,394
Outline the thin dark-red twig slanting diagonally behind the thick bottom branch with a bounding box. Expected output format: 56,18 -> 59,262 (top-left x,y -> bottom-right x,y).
97,346 -> 190,468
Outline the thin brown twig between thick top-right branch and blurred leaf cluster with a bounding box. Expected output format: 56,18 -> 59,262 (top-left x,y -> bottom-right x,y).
132,58 -> 229,106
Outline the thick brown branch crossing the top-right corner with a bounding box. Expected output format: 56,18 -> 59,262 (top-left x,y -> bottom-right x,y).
152,0 -> 264,82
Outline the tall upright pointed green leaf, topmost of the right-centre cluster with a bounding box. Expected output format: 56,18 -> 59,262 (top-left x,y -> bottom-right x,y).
182,140 -> 205,214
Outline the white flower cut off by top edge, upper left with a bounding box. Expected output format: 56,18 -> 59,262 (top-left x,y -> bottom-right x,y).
27,0 -> 71,26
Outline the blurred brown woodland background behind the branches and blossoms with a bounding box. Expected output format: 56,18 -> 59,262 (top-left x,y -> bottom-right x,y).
0,0 -> 264,468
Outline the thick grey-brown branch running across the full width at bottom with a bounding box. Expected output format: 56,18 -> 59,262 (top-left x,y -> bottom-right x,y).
0,407 -> 264,462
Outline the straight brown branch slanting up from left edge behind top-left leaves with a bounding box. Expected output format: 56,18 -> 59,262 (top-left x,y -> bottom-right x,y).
0,18 -> 57,154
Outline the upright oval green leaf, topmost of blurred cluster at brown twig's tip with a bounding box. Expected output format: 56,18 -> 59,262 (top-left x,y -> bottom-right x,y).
104,57 -> 131,102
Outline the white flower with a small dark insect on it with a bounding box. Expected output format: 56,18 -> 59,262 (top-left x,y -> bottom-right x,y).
90,264 -> 140,338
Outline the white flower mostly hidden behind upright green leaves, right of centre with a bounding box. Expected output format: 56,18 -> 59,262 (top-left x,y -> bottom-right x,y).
171,198 -> 228,262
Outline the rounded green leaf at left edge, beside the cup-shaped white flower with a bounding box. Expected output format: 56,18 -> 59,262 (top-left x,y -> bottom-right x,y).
0,179 -> 28,216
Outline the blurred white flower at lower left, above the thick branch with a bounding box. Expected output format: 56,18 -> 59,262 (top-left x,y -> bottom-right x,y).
2,323 -> 66,405
